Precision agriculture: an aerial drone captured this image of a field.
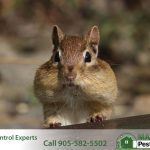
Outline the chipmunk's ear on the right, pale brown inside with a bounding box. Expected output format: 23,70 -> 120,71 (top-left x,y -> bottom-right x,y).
85,26 -> 100,45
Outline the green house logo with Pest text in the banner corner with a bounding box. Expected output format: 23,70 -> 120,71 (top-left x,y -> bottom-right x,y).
116,134 -> 150,150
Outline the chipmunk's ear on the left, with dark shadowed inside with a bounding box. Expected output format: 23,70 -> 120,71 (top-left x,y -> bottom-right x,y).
52,25 -> 64,47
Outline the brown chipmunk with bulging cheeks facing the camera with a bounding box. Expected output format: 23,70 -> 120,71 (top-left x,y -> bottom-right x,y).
34,25 -> 117,127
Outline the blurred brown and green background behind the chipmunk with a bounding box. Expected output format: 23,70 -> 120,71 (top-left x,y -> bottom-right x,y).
0,0 -> 150,128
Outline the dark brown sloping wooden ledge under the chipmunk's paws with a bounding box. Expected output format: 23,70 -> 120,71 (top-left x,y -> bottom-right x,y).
55,114 -> 150,129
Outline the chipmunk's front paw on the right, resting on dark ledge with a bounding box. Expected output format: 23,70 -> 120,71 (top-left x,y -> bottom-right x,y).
87,113 -> 106,123
